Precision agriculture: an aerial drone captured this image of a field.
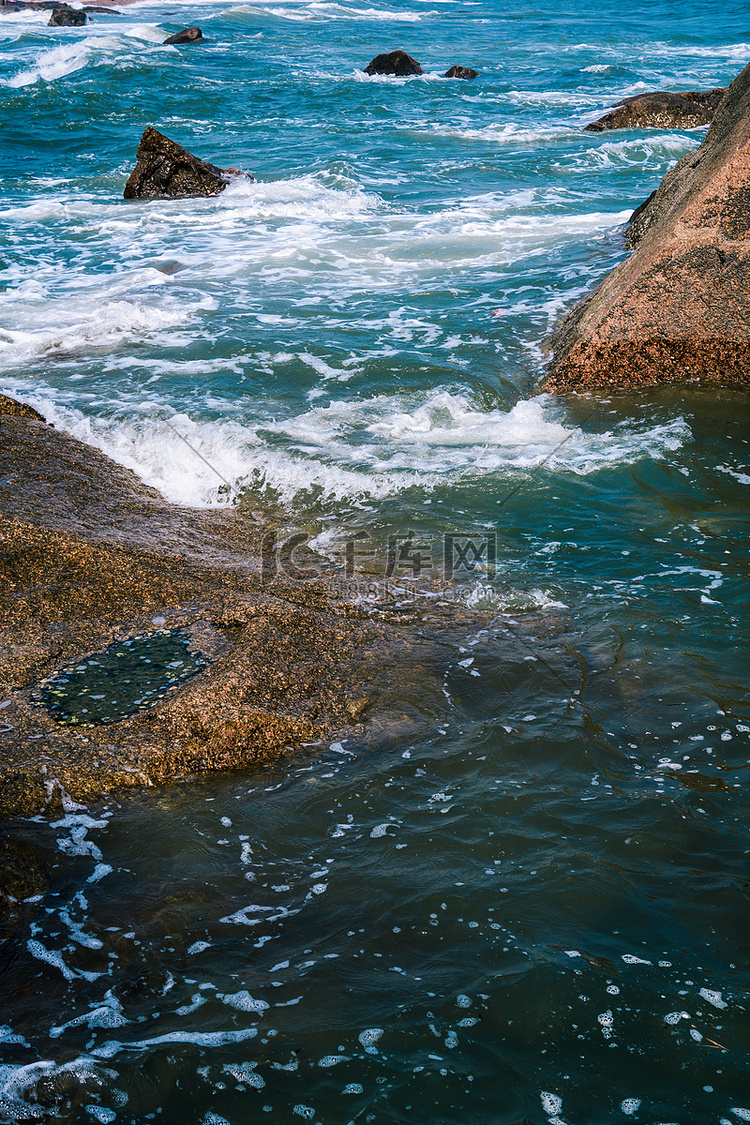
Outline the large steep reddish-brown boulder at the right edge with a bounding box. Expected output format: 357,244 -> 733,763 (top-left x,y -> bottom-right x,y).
543,64 -> 750,390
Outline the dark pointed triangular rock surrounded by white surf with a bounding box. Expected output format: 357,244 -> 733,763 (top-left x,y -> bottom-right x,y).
124,125 -> 246,199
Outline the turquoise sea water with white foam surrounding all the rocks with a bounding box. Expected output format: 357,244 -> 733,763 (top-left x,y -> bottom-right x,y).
0,0 -> 750,1125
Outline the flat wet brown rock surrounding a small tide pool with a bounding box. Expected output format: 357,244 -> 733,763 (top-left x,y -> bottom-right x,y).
0,399 -> 521,817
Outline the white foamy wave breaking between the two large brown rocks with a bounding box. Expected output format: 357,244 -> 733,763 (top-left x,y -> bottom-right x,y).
9,386 -> 689,510
